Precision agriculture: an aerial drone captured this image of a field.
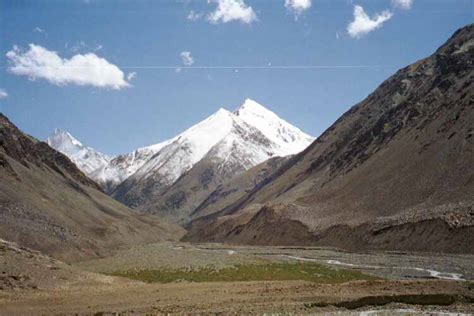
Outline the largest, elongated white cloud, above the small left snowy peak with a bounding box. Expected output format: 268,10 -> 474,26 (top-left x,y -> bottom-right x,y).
6,44 -> 129,90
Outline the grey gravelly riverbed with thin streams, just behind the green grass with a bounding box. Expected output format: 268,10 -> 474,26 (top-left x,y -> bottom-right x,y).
76,243 -> 474,280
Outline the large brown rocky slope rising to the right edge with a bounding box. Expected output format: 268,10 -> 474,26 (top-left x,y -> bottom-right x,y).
184,25 -> 474,253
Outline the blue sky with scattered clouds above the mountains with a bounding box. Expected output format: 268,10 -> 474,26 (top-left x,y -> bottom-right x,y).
0,0 -> 474,154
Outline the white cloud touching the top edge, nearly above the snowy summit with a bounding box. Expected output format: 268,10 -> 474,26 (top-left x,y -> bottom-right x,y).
207,0 -> 257,24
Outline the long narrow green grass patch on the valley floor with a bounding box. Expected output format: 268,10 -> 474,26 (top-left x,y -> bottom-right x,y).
112,263 -> 378,283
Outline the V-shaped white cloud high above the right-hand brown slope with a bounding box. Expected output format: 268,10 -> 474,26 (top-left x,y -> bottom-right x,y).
347,5 -> 393,38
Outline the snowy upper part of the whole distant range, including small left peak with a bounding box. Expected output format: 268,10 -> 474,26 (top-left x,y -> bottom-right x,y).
47,99 -> 313,198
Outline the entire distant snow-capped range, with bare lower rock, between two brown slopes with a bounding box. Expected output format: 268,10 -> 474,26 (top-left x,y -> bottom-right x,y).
47,99 -> 314,221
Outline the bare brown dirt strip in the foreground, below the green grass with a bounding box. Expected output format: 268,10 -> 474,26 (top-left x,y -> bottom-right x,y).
0,279 -> 473,315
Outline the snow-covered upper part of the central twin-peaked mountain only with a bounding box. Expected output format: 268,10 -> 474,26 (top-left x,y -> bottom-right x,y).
126,99 -> 313,191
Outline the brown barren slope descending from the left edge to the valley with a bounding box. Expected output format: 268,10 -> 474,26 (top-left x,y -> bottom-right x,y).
0,114 -> 182,261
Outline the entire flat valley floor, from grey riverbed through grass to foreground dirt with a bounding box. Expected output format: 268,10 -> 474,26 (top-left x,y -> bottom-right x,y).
0,243 -> 474,315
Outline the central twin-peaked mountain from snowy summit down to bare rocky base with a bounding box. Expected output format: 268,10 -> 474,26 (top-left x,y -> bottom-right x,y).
113,100 -> 313,223
